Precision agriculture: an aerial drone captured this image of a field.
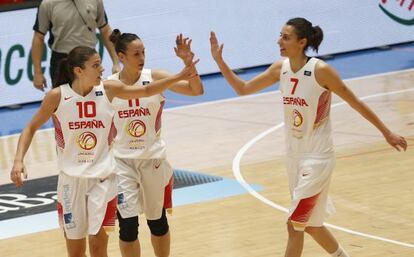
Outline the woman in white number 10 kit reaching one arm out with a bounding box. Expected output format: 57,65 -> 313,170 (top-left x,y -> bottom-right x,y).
10,47 -> 196,257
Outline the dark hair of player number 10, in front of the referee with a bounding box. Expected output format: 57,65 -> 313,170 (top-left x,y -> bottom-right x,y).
53,46 -> 97,87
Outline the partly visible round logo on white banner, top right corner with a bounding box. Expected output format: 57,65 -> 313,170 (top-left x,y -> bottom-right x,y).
378,0 -> 414,26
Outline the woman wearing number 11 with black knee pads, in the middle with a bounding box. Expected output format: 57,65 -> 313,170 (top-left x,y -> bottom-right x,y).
109,29 -> 203,257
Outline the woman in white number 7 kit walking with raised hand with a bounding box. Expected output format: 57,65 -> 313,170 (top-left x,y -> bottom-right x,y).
210,18 -> 407,257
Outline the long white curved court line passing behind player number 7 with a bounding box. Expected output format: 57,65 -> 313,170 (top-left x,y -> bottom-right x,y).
233,88 -> 414,248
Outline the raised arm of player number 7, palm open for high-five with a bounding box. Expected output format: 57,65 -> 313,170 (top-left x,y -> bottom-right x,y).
210,32 -> 282,95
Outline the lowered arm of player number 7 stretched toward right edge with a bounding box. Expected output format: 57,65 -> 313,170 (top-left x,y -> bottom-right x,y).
315,61 -> 407,151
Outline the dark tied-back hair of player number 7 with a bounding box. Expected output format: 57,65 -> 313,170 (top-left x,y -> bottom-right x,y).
286,18 -> 323,52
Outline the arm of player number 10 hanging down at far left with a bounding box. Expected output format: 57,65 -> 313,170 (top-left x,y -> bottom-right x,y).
10,88 -> 60,187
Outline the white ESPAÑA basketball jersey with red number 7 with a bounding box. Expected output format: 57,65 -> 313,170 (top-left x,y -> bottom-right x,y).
280,58 -> 333,155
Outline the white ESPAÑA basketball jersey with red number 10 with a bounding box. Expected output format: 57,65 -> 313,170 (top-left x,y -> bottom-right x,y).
52,83 -> 116,179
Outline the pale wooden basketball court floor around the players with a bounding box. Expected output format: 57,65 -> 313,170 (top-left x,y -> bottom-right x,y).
0,71 -> 414,257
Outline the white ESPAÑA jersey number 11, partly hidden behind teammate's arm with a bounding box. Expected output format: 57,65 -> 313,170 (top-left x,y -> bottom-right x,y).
108,69 -> 166,159
